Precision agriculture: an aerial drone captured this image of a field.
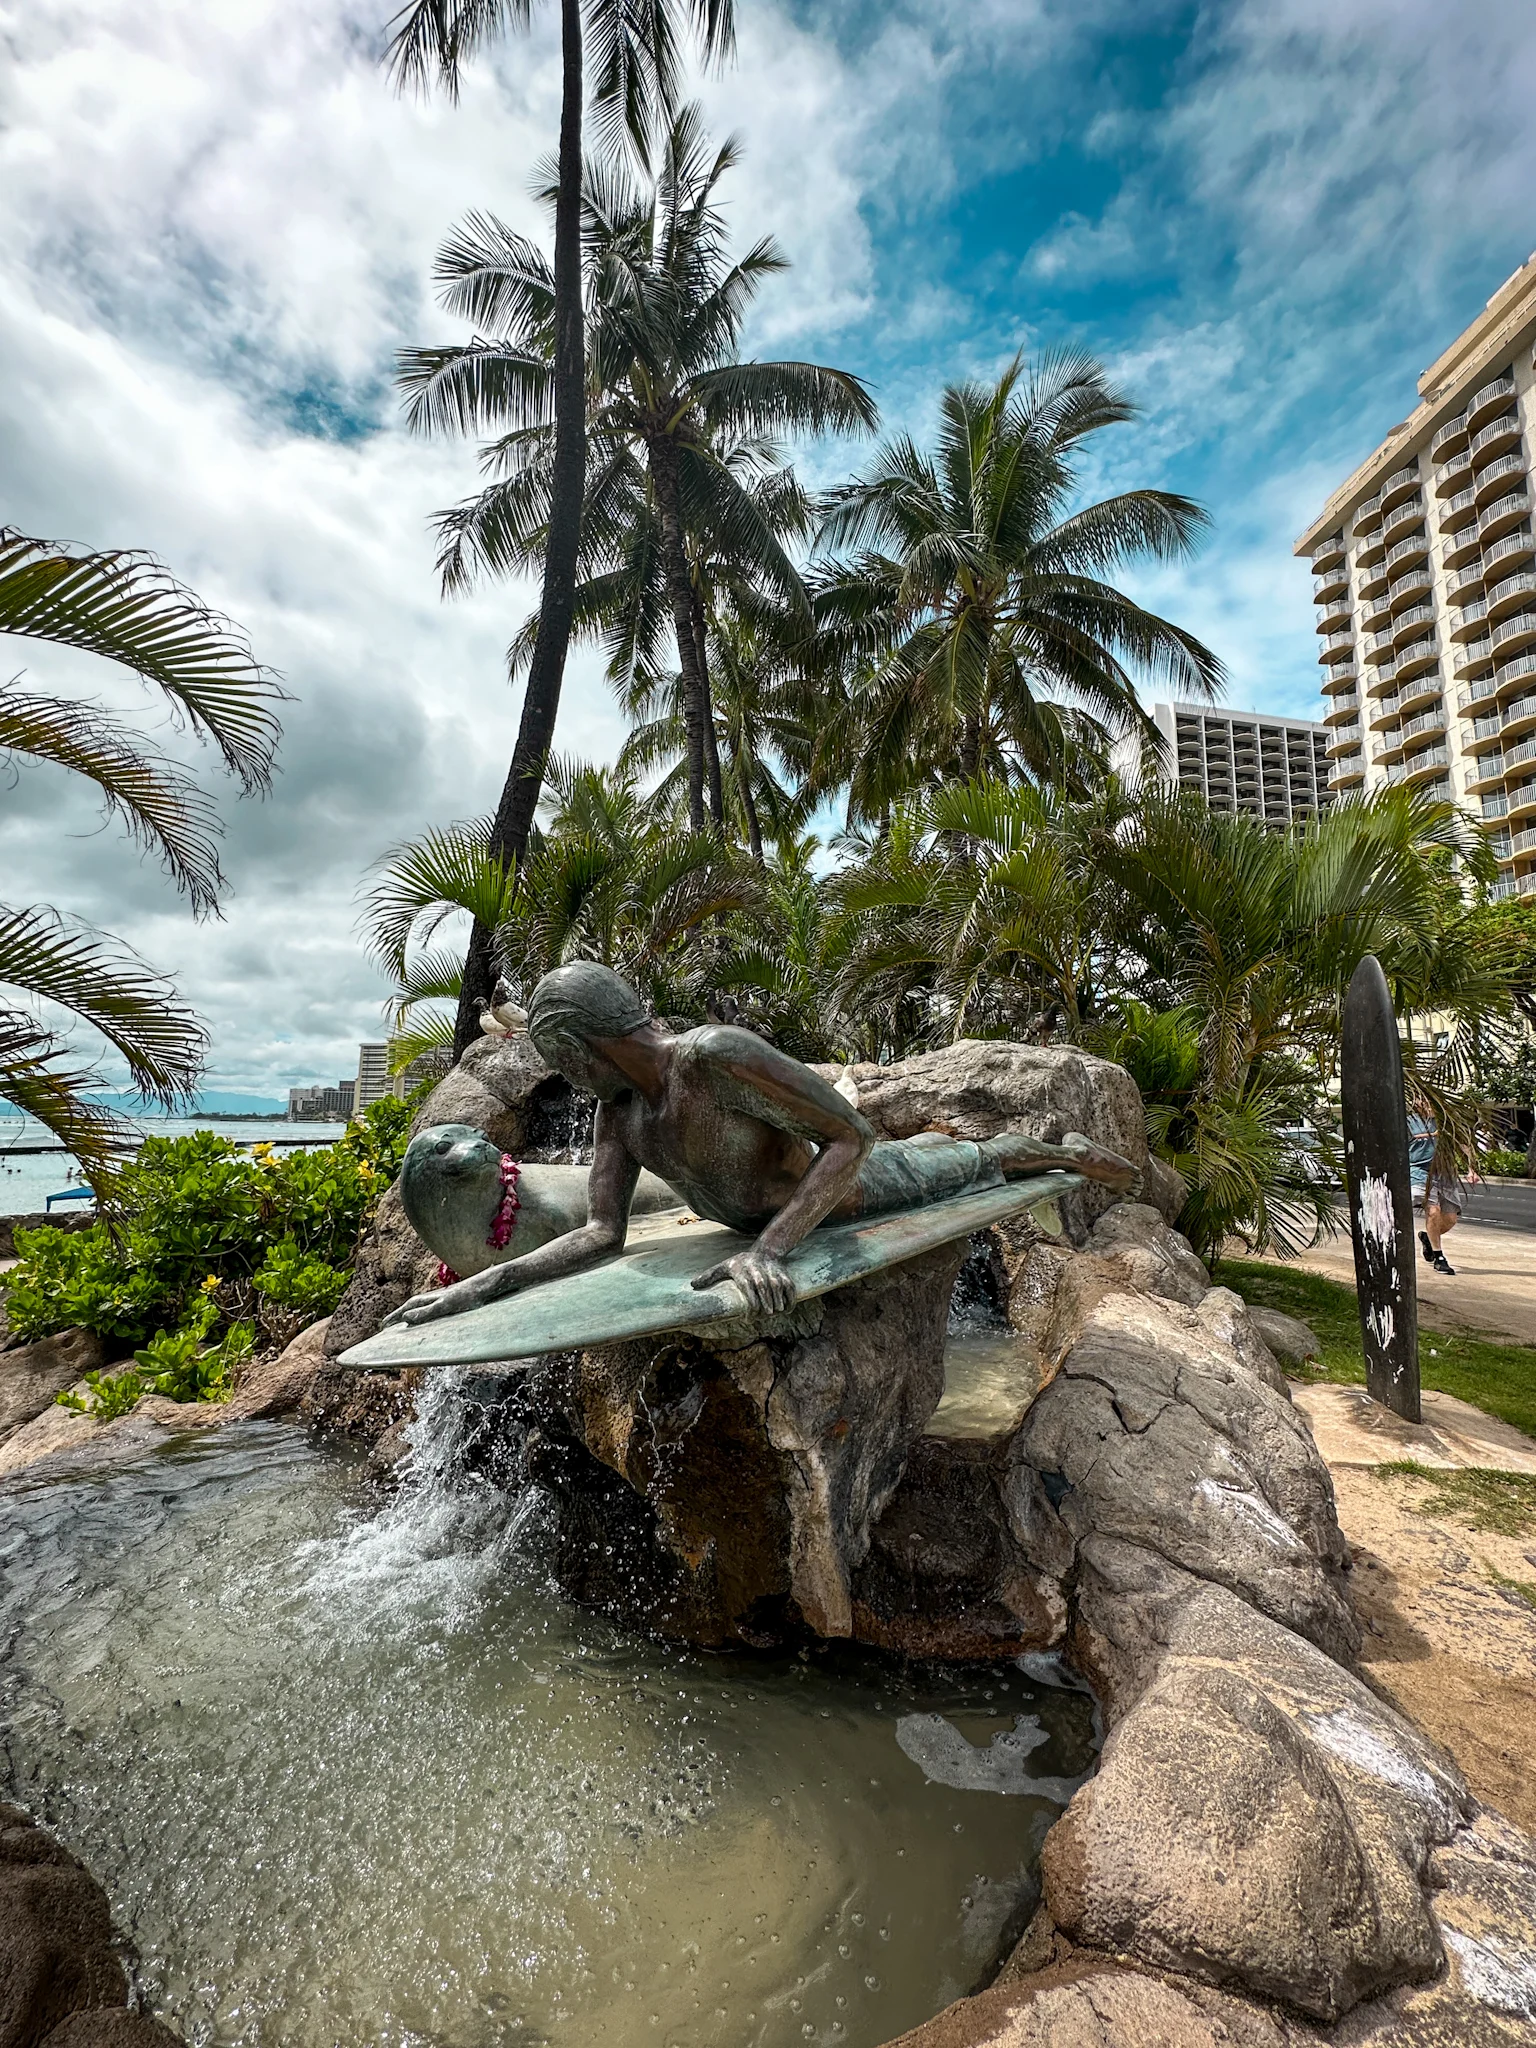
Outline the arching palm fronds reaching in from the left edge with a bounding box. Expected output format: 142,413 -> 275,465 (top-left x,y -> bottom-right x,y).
0,528 -> 283,1192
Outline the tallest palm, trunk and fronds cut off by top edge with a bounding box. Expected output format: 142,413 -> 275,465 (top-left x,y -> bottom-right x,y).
387,0 -> 735,1049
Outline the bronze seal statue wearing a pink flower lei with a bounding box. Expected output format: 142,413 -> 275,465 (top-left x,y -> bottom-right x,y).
399,1124 -> 682,1280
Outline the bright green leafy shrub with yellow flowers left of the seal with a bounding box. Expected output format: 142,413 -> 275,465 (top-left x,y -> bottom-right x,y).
12,1098 -> 416,1351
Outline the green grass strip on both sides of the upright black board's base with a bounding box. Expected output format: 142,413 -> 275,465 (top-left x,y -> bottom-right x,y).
1214,1260 -> 1536,1436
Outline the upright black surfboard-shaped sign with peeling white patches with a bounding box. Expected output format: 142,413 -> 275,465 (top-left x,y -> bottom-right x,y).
1339,952 -> 1421,1421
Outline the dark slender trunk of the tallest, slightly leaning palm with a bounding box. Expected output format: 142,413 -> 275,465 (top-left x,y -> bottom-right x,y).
453,0 -> 586,1059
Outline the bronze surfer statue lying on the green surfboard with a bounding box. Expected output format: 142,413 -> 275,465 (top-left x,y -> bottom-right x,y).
389,961 -> 1137,1323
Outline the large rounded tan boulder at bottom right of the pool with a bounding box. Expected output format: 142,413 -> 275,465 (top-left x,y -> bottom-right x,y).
1042,1585 -> 1473,2019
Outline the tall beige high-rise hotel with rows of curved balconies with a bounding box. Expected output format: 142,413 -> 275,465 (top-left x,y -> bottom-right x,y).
1296,256 -> 1536,895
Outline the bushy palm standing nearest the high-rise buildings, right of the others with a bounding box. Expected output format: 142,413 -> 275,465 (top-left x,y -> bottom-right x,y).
817,354 -> 1223,819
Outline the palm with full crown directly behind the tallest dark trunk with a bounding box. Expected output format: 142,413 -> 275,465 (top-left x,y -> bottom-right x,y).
401,109 -> 874,856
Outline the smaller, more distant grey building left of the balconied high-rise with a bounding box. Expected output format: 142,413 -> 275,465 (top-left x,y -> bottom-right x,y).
1114,705 -> 1331,825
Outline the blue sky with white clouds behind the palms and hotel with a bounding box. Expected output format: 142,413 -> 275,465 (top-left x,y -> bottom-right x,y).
0,0 -> 1536,1090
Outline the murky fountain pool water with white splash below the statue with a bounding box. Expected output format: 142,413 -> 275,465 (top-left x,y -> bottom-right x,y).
0,1374 -> 1092,2048
